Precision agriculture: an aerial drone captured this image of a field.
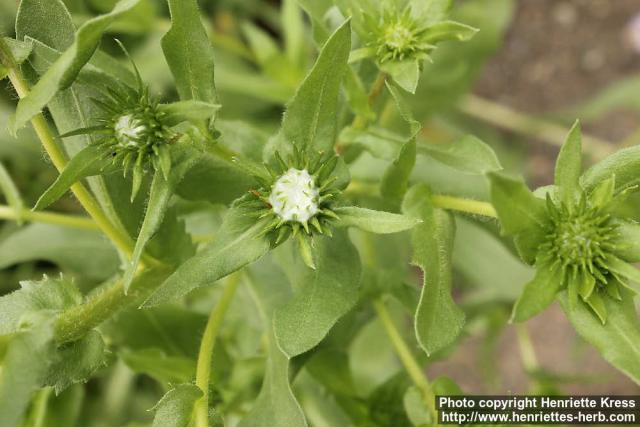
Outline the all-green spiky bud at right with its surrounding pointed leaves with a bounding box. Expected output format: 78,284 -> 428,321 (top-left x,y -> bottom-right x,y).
490,123 -> 640,324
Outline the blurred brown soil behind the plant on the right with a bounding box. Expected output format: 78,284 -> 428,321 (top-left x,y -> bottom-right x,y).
429,0 -> 640,394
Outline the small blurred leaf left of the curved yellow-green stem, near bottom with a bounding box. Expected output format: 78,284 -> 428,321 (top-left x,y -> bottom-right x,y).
120,348 -> 196,384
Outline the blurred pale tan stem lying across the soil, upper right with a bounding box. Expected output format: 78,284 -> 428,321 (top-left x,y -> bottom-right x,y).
458,95 -> 615,159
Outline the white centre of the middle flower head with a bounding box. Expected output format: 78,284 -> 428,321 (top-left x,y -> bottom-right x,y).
269,168 -> 320,222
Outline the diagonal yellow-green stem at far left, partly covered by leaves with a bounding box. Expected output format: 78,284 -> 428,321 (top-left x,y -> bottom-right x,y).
0,39 -> 133,256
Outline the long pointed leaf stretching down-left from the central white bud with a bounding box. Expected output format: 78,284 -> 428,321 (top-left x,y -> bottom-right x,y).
144,198 -> 272,306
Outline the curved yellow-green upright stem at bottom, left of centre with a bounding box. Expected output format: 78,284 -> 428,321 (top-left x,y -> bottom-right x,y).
194,273 -> 240,427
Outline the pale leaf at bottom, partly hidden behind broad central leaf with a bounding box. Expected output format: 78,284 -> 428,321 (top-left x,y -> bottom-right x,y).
239,257 -> 307,427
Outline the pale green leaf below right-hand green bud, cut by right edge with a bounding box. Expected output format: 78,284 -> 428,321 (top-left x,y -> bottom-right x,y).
559,292 -> 640,384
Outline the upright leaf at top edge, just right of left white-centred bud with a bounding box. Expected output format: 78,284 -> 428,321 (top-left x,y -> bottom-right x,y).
162,0 -> 217,104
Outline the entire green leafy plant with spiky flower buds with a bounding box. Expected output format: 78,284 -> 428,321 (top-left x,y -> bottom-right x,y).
0,0 -> 640,427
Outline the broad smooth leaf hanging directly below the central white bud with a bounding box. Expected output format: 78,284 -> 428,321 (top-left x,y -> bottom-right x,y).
273,230 -> 361,357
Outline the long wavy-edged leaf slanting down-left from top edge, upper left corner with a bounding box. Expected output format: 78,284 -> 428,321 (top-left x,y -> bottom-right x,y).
11,0 -> 139,133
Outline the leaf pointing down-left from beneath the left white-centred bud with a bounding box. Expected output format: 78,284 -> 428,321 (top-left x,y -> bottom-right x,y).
33,144 -> 111,210
